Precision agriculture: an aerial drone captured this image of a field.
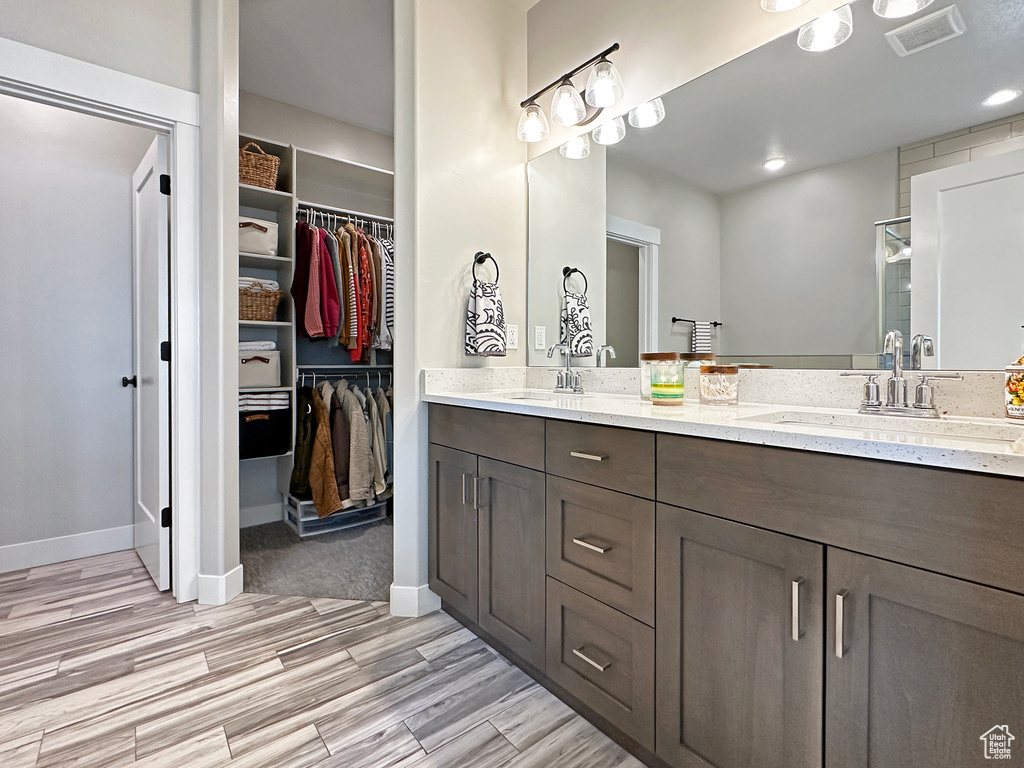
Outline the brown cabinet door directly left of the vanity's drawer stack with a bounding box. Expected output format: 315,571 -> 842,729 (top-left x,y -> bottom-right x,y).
477,458 -> 545,672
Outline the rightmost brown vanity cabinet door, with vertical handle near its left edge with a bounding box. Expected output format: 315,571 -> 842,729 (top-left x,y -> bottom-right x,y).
825,548 -> 1024,768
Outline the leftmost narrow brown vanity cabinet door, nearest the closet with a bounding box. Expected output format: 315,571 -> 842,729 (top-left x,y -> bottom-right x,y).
428,444 -> 477,622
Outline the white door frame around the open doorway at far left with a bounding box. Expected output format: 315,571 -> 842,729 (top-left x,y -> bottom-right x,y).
0,38 -> 201,602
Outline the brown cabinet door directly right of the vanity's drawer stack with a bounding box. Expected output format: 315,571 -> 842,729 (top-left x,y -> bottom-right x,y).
656,505 -> 824,768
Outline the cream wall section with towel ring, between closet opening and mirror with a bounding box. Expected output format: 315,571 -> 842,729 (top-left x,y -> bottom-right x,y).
391,0 -> 526,613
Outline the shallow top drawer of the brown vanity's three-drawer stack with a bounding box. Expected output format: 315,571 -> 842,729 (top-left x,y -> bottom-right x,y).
546,420 -> 654,499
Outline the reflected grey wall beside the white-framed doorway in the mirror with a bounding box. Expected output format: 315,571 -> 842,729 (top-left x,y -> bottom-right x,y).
608,150 -> 722,352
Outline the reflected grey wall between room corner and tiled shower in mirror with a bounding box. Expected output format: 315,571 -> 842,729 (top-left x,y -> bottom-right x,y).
719,150 -> 898,355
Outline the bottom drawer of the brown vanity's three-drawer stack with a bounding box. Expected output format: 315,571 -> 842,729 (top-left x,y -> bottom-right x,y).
548,578 -> 654,750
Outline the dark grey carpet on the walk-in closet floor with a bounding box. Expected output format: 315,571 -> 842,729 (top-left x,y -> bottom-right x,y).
240,516 -> 394,601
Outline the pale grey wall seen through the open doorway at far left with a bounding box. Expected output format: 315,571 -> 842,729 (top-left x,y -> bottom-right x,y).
0,96 -> 154,571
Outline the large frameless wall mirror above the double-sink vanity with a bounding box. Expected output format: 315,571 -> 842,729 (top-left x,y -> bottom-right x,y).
527,0 -> 1024,370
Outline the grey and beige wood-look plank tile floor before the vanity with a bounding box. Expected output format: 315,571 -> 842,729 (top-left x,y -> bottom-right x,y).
0,552 -> 641,768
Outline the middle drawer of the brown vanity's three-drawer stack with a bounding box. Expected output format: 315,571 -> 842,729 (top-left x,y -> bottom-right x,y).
547,475 -> 654,625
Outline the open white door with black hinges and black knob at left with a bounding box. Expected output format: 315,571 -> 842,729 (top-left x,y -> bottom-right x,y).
132,136 -> 171,590
